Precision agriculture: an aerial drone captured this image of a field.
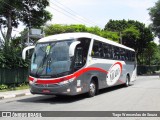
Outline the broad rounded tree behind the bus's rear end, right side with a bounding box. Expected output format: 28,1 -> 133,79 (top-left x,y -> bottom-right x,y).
104,20 -> 153,64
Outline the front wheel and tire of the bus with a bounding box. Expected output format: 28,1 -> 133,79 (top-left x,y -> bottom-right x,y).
88,80 -> 97,97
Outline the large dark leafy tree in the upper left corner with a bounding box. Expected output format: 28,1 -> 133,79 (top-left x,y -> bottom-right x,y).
0,0 -> 52,44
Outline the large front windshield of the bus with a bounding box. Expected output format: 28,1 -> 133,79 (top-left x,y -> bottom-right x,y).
30,40 -> 73,78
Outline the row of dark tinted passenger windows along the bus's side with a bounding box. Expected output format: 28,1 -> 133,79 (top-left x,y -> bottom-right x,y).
92,40 -> 135,61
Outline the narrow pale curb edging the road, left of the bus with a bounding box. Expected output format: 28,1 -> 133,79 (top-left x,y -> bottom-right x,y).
0,92 -> 31,100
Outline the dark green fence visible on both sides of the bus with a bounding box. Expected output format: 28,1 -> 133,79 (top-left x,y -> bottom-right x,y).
0,65 -> 160,85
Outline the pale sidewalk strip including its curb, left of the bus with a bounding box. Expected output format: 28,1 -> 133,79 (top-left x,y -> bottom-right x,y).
0,89 -> 31,100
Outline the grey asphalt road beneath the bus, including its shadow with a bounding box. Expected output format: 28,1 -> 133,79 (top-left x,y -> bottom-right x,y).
0,76 -> 160,120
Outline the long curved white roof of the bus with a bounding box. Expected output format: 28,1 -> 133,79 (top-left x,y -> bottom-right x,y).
38,32 -> 135,51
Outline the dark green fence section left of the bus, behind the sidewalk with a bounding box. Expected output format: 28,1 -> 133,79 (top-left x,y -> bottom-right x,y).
0,68 -> 28,85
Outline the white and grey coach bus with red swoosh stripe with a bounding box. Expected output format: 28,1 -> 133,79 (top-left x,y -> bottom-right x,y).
22,33 -> 136,97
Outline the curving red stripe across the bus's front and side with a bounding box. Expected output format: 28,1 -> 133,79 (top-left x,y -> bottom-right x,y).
29,67 -> 108,84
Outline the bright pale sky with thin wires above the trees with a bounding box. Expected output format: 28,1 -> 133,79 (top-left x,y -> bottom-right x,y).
10,0 -> 158,44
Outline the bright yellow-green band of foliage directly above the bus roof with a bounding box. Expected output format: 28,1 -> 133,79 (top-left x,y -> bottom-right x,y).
45,24 -> 119,42
